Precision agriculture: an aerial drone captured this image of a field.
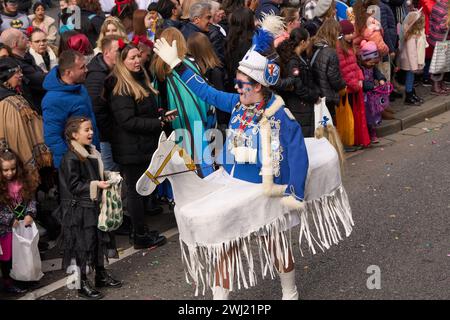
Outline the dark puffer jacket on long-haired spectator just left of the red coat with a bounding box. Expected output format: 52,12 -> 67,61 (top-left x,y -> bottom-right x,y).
311,42 -> 345,115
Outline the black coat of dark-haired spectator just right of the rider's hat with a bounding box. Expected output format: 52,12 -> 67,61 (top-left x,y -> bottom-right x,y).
274,57 -> 320,137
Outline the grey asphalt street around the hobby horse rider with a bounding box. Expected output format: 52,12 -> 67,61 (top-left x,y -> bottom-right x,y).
29,112 -> 450,300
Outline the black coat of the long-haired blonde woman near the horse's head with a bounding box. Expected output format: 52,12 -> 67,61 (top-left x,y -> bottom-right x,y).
107,71 -> 162,165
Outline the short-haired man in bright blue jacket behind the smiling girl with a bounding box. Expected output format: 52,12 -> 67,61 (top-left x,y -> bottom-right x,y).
42,50 -> 100,168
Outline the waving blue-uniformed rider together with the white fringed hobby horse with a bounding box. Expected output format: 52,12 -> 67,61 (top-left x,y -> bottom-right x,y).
136,12 -> 353,299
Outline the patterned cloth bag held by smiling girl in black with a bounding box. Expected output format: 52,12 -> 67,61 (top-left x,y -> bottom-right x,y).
97,171 -> 123,232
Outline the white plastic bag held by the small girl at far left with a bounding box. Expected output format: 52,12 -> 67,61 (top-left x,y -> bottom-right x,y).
10,221 -> 44,281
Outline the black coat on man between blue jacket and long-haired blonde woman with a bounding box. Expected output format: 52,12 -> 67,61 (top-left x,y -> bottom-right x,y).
84,53 -> 114,142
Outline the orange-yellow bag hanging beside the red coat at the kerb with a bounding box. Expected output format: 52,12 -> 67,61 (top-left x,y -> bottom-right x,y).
336,94 -> 355,146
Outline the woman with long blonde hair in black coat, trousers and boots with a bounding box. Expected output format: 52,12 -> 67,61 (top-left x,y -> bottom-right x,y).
105,39 -> 173,249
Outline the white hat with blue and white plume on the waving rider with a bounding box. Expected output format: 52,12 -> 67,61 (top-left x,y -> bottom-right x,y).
238,14 -> 284,87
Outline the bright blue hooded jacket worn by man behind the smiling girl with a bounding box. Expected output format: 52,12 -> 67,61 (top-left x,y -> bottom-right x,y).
42,67 -> 99,168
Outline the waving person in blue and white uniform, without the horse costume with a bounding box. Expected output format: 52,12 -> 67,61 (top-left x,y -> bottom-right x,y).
154,18 -> 308,300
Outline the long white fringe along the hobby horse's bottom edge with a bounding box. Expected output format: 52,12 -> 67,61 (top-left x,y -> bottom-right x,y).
180,186 -> 354,295
